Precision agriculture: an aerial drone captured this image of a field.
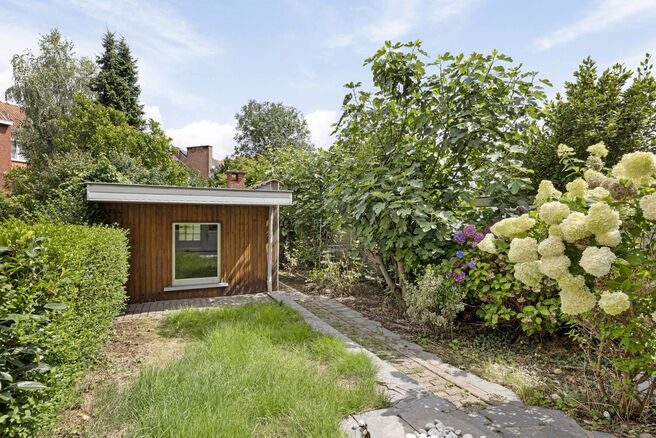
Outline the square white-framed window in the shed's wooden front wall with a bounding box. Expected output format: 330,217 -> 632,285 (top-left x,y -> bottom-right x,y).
173,223 -> 221,285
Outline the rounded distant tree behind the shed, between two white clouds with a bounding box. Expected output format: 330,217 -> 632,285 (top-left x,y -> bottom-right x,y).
234,100 -> 314,157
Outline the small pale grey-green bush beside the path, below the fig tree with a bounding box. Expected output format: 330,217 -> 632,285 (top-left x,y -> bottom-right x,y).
406,266 -> 465,330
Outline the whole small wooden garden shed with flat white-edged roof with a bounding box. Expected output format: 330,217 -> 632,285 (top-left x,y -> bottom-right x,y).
87,174 -> 292,303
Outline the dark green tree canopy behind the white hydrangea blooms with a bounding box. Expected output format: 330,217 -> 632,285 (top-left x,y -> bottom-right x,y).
525,55 -> 656,188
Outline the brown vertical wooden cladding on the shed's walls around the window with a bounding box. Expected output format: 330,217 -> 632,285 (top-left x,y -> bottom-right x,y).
103,203 -> 278,303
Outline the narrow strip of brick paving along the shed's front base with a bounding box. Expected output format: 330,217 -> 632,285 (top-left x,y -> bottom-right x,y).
118,293 -> 272,321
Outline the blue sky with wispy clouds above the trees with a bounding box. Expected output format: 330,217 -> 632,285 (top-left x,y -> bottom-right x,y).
0,0 -> 656,158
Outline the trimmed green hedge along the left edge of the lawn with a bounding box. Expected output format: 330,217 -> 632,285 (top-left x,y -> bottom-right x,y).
0,219 -> 129,437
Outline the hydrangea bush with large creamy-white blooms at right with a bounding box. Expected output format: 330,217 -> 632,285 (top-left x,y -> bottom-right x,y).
477,143 -> 656,419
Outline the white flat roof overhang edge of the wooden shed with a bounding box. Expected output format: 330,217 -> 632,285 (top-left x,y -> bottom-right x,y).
86,182 -> 292,205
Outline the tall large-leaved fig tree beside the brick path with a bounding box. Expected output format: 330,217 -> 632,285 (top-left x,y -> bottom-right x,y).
326,41 -> 548,301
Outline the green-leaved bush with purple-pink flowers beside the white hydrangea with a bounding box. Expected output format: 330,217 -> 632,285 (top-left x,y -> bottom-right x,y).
439,225 -> 562,335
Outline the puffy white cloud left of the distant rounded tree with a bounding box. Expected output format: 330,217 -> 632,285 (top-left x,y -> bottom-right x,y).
166,120 -> 235,160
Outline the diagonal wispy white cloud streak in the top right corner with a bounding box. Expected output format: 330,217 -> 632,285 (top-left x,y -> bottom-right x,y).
537,0 -> 656,50
